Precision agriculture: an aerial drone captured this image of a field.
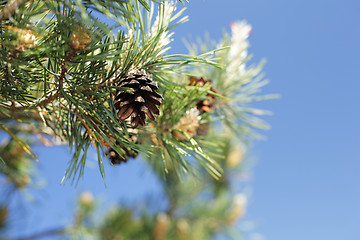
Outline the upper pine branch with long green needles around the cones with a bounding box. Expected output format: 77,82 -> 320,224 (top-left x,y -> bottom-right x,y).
0,0 -> 267,184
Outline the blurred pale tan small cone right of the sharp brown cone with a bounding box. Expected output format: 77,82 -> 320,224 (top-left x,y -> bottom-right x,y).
173,108 -> 201,141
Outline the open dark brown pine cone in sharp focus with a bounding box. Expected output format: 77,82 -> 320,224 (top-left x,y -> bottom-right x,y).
114,70 -> 163,128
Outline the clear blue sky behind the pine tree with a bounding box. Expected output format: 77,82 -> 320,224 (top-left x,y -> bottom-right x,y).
7,0 -> 360,240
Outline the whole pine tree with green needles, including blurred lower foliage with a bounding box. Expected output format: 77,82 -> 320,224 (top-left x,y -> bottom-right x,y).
0,0 -> 273,240
